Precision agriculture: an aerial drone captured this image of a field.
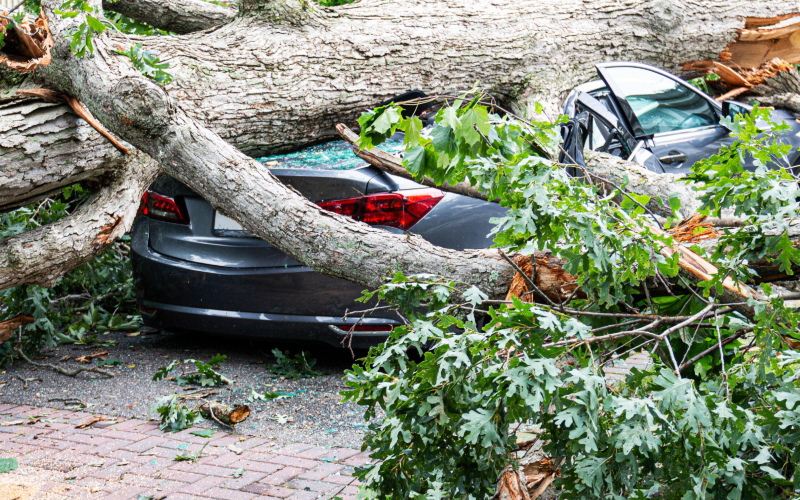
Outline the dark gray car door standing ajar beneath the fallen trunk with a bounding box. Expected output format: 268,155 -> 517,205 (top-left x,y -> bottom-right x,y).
596,62 -> 732,174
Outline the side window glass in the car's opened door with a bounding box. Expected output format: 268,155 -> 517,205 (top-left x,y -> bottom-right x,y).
605,66 -> 718,134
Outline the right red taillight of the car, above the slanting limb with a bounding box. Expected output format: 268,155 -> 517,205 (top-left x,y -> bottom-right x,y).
319,189 -> 444,231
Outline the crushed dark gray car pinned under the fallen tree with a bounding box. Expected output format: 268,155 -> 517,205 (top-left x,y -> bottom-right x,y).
132,62 -> 800,347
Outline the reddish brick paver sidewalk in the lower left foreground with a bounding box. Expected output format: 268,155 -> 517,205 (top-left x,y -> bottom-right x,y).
0,404 -> 369,500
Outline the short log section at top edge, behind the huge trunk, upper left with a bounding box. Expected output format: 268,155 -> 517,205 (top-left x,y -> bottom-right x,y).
103,0 -> 236,34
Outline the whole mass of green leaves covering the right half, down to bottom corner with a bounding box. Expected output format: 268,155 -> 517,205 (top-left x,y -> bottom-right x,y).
343,95 -> 800,500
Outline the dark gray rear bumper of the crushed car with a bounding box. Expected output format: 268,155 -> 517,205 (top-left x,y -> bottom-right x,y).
131,217 -> 400,348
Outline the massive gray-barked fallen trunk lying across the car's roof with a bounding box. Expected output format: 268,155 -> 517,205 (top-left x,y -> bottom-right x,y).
108,0 -> 800,156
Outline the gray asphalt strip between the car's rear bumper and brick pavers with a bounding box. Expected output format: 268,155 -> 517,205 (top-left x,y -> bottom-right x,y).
0,333 -> 376,448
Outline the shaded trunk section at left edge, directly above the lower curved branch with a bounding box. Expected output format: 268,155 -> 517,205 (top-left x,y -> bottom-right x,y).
0,93 -> 122,210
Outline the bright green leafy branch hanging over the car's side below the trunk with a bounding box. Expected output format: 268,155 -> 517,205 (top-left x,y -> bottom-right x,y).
359,94 -> 678,305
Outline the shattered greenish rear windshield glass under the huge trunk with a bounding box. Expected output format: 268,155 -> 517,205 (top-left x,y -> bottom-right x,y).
256,134 -> 405,170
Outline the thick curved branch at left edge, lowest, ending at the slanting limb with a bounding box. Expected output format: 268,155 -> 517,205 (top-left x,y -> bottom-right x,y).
0,153 -> 158,290
